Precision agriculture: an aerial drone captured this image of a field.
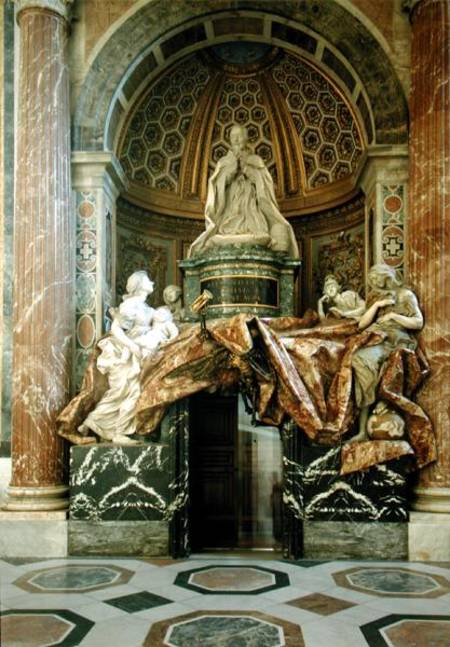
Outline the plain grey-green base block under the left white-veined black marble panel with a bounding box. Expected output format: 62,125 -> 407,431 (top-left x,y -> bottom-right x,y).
69,520 -> 169,557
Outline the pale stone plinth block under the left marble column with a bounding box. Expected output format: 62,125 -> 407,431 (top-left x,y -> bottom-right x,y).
0,511 -> 68,558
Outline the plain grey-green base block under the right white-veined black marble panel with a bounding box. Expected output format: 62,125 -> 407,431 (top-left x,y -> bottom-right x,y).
303,521 -> 408,560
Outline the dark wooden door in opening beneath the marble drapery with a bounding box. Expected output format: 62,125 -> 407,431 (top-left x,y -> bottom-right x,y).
189,394 -> 238,551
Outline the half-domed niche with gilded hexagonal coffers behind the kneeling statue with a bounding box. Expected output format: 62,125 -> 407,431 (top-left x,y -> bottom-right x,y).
117,42 -> 366,309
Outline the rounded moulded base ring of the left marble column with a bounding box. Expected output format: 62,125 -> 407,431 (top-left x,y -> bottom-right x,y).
3,485 -> 69,512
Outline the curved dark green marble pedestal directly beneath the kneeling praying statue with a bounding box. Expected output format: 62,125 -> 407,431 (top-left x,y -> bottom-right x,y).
179,245 -> 301,321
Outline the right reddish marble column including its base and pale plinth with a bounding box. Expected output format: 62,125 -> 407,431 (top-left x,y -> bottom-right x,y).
407,0 -> 450,559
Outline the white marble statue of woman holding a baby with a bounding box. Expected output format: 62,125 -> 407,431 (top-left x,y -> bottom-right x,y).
78,271 -> 178,444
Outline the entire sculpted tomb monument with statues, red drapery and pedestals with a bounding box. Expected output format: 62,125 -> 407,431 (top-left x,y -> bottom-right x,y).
59,121 -> 436,558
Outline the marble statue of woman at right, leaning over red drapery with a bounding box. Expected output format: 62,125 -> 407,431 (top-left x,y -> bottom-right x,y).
352,263 -> 423,441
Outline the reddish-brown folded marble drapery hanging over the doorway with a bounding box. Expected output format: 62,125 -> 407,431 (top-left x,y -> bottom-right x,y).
59,313 -> 436,473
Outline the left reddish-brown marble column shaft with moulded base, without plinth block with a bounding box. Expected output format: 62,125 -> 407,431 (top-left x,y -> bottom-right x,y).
6,0 -> 75,511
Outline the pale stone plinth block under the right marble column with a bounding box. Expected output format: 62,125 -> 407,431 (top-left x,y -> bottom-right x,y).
408,512 -> 450,562
